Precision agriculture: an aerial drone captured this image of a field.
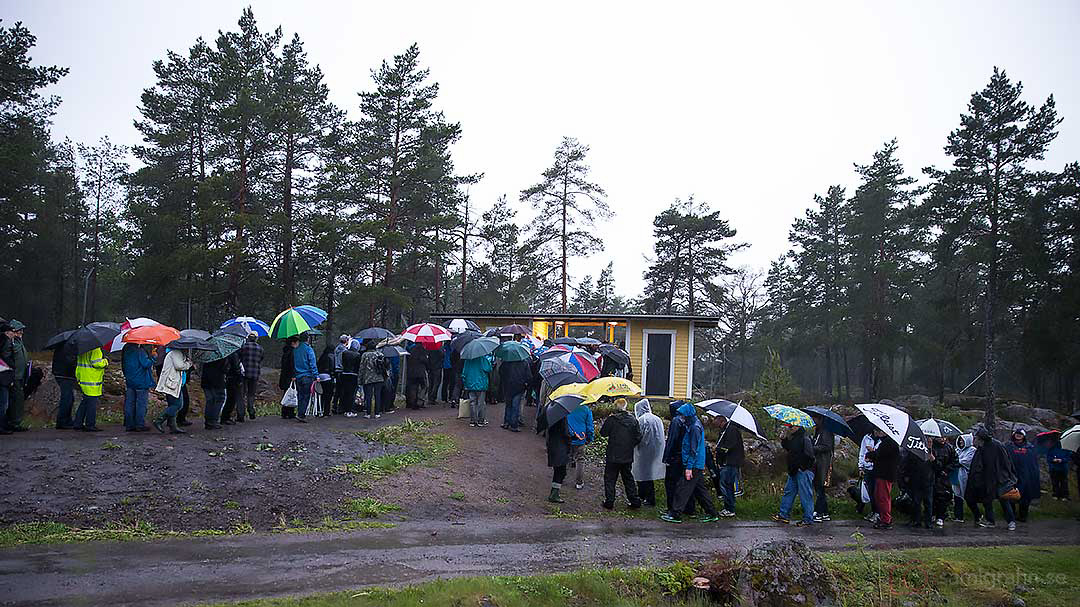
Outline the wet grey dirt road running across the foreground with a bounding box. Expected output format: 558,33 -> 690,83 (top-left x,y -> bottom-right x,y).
0,518 -> 1080,607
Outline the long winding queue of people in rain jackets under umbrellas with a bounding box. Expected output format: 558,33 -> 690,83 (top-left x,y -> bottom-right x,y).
0,320 -> 1080,530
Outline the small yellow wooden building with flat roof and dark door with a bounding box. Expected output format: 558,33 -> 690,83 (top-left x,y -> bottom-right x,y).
431,313 -> 717,399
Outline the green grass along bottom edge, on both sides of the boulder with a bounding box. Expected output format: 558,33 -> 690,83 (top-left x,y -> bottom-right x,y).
198,547 -> 1080,607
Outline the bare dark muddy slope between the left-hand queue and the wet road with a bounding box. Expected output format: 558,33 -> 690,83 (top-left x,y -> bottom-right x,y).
0,352 -> 602,531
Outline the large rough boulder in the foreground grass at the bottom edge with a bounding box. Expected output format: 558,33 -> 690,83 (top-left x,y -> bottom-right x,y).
698,540 -> 839,607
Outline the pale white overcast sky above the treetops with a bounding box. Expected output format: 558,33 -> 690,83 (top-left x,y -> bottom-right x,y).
8,0 -> 1080,295
